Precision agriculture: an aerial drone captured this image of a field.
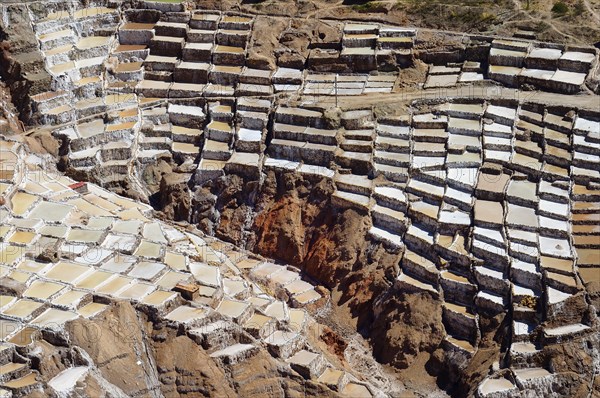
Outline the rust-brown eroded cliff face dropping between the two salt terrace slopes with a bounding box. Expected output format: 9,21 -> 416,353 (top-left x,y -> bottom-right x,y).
183,171 -> 454,394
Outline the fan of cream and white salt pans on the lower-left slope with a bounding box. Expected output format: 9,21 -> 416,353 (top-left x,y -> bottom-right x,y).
0,136 -> 384,395
